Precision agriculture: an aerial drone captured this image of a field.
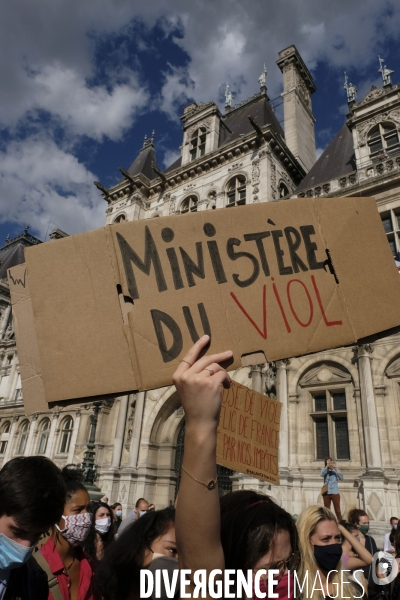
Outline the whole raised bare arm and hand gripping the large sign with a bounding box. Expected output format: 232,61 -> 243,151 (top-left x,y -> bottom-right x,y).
173,336 -> 232,572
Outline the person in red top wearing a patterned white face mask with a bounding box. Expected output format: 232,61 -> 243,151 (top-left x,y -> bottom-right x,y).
39,465 -> 100,600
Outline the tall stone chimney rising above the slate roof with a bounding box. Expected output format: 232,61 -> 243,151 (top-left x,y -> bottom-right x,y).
276,46 -> 317,171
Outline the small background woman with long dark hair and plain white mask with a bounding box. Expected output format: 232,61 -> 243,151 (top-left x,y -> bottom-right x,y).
82,501 -> 115,564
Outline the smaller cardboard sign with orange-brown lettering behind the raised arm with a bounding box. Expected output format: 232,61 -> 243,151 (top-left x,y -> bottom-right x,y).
217,381 -> 282,485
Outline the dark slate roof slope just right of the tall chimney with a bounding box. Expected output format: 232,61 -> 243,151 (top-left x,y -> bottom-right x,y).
296,123 -> 356,193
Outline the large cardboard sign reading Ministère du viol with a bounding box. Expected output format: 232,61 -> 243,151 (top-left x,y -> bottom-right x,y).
9,198 -> 400,404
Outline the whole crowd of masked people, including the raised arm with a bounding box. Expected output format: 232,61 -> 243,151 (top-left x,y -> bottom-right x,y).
0,336 -> 400,600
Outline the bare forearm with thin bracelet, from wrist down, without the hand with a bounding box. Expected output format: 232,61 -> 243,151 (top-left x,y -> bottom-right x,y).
176,423 -> 224,570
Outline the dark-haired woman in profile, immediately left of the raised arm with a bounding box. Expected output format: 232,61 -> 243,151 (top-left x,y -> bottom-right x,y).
96,508 -> 178,600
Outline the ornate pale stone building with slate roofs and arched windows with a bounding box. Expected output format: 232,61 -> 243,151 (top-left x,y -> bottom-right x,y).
0,46 -> 400,539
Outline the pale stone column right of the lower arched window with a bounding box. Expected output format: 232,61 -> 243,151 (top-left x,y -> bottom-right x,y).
357,344 -> 382,474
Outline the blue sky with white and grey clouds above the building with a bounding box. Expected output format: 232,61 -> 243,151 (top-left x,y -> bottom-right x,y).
0,0 -> 400,244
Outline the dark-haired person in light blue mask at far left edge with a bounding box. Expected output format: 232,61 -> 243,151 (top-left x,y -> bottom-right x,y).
0,456 -> 65,600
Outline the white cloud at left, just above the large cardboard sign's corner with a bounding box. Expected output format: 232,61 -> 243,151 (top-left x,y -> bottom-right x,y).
0,137 -> 106,239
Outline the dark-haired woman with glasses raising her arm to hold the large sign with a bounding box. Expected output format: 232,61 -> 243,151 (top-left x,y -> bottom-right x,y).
173,336 -> 300,598
